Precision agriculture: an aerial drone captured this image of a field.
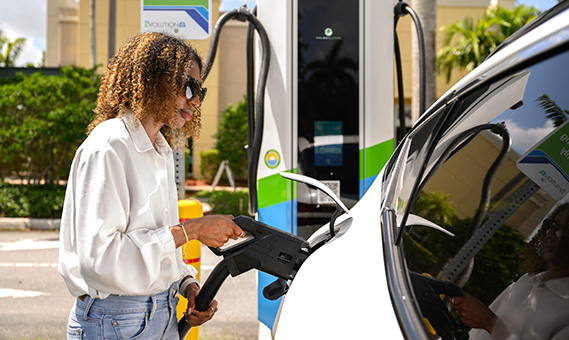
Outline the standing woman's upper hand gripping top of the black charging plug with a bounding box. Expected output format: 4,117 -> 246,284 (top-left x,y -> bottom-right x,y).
183,215 -> 245,247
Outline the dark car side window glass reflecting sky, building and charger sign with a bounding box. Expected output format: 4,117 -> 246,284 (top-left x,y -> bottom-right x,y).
398,52 -> 569,339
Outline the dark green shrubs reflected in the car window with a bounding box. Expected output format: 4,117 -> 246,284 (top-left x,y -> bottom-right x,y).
403,192 -> 524,305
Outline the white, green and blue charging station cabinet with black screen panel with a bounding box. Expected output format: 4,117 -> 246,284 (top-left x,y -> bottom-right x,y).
256,0 -> 395,338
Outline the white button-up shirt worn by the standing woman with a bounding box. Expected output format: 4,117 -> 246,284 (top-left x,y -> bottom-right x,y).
59,113 -> 196,298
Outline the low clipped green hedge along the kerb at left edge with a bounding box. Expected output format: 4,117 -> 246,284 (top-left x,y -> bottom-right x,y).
0,184 -> 65,218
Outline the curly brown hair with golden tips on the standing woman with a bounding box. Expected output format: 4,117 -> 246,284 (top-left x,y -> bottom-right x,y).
87,33 -> 203,149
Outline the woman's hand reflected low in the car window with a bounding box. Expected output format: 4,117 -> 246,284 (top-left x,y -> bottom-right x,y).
449,292 -> 497,333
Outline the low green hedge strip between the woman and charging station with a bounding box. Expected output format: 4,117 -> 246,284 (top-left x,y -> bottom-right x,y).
196,190 -> 249,216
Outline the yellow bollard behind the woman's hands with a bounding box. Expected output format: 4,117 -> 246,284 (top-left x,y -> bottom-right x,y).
180,198 -> 203,340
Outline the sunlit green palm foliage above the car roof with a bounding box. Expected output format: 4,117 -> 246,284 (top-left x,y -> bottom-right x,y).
436,5 -> 540,82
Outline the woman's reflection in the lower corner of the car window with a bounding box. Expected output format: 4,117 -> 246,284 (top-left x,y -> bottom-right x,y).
450,203 -> 569,340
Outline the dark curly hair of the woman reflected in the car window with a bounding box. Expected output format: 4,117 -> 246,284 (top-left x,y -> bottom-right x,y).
520,203 -> 569,274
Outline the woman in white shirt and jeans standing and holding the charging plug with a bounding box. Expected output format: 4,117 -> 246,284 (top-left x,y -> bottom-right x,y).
59,33 -> 244,339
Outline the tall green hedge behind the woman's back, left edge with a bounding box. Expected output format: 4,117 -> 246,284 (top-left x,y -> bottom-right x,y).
0,66 -> 99,184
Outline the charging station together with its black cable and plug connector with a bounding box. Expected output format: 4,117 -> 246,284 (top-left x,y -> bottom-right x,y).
175,0 -> 395,339
